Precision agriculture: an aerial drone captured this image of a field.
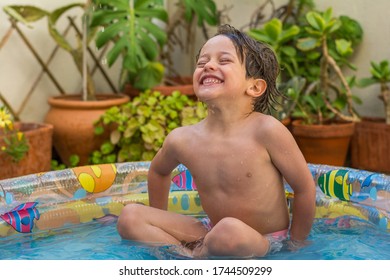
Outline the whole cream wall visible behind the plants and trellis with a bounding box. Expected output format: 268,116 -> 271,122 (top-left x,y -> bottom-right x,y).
0,0 -> 390,121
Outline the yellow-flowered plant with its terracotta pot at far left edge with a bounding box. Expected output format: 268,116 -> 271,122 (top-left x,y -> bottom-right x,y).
0,107 -> 53,180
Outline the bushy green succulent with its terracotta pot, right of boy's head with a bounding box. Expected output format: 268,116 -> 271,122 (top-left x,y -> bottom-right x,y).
251,8 -> 362,165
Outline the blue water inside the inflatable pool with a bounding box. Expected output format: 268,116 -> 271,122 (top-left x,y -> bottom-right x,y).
0,217 -> 390,260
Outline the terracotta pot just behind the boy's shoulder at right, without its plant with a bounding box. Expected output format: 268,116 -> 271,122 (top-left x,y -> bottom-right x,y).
291,120 -> 355,166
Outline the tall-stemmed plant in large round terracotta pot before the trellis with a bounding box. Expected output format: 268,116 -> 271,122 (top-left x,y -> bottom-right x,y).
4,3 -> 129,165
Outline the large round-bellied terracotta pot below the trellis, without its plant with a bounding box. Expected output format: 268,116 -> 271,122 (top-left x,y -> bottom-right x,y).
45,94 -> 129,165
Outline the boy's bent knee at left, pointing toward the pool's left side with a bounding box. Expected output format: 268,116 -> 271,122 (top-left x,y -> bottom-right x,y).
117,204 -> 145,239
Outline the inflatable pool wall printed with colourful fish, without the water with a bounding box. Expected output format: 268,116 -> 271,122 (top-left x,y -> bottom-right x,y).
0,162 -> 390,253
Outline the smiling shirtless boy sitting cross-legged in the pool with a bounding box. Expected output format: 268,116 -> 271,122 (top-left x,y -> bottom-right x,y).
118,25 -> 315,257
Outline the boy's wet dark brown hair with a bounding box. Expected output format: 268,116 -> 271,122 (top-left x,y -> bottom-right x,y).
210,24 -> 282,113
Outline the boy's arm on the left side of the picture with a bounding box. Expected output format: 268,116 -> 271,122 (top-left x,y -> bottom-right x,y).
148,130 -> 179,210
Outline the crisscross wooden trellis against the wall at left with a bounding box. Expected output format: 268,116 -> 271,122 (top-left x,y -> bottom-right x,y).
0,17 -> 118,121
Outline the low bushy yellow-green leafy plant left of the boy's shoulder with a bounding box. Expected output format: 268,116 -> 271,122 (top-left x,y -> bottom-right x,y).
90,91 -> 207,164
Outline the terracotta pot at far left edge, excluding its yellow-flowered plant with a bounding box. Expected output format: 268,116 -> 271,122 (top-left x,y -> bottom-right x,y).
0,123 -> 53,179
